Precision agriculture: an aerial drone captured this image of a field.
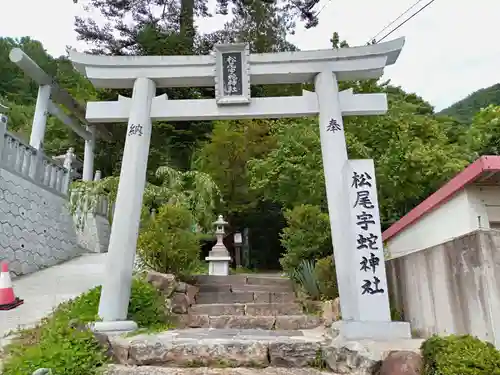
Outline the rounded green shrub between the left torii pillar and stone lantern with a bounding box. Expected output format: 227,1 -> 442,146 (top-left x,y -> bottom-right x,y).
137,205 -> 200,276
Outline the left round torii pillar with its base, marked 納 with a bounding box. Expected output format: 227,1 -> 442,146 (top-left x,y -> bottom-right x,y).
93,78 -> 156,332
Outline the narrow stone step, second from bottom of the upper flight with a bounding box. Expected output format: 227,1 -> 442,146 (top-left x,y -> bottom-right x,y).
190,302 -> 303,316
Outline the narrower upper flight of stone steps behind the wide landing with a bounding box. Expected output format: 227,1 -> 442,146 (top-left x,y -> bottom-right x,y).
179,275 -> 322,330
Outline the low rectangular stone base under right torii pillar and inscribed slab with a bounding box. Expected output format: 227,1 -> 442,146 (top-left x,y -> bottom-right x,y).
331,320 -> 411,341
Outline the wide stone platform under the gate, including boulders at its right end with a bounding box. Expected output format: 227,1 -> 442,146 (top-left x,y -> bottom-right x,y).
106,329 -> 423,375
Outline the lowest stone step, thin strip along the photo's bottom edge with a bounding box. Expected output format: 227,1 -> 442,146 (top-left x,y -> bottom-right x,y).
104,365 -> 332,375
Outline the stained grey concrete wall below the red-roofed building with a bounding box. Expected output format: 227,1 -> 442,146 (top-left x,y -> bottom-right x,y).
387,229 -> 500,347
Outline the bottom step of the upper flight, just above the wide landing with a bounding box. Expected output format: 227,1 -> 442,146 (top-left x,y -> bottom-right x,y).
178,314 -> 323,330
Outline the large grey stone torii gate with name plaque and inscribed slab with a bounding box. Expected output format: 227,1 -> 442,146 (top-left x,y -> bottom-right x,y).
70,38 -> 410,339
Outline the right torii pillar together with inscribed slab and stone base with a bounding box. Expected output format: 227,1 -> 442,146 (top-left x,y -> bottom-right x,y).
315,70 -> 411,340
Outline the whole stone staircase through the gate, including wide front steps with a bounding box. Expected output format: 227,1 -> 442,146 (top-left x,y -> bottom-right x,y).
107,275 -> 332,375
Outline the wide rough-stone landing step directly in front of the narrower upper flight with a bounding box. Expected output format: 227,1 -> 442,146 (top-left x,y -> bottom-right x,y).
110,329 -> 323,368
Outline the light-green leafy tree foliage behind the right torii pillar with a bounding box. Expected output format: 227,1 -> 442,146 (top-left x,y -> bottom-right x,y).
248,88 -> 470,228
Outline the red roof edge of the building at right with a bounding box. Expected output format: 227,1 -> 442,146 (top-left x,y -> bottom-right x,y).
382,155 -> 500,241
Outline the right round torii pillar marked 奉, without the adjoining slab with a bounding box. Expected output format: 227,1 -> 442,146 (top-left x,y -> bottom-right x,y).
314,71 -> 356,320
